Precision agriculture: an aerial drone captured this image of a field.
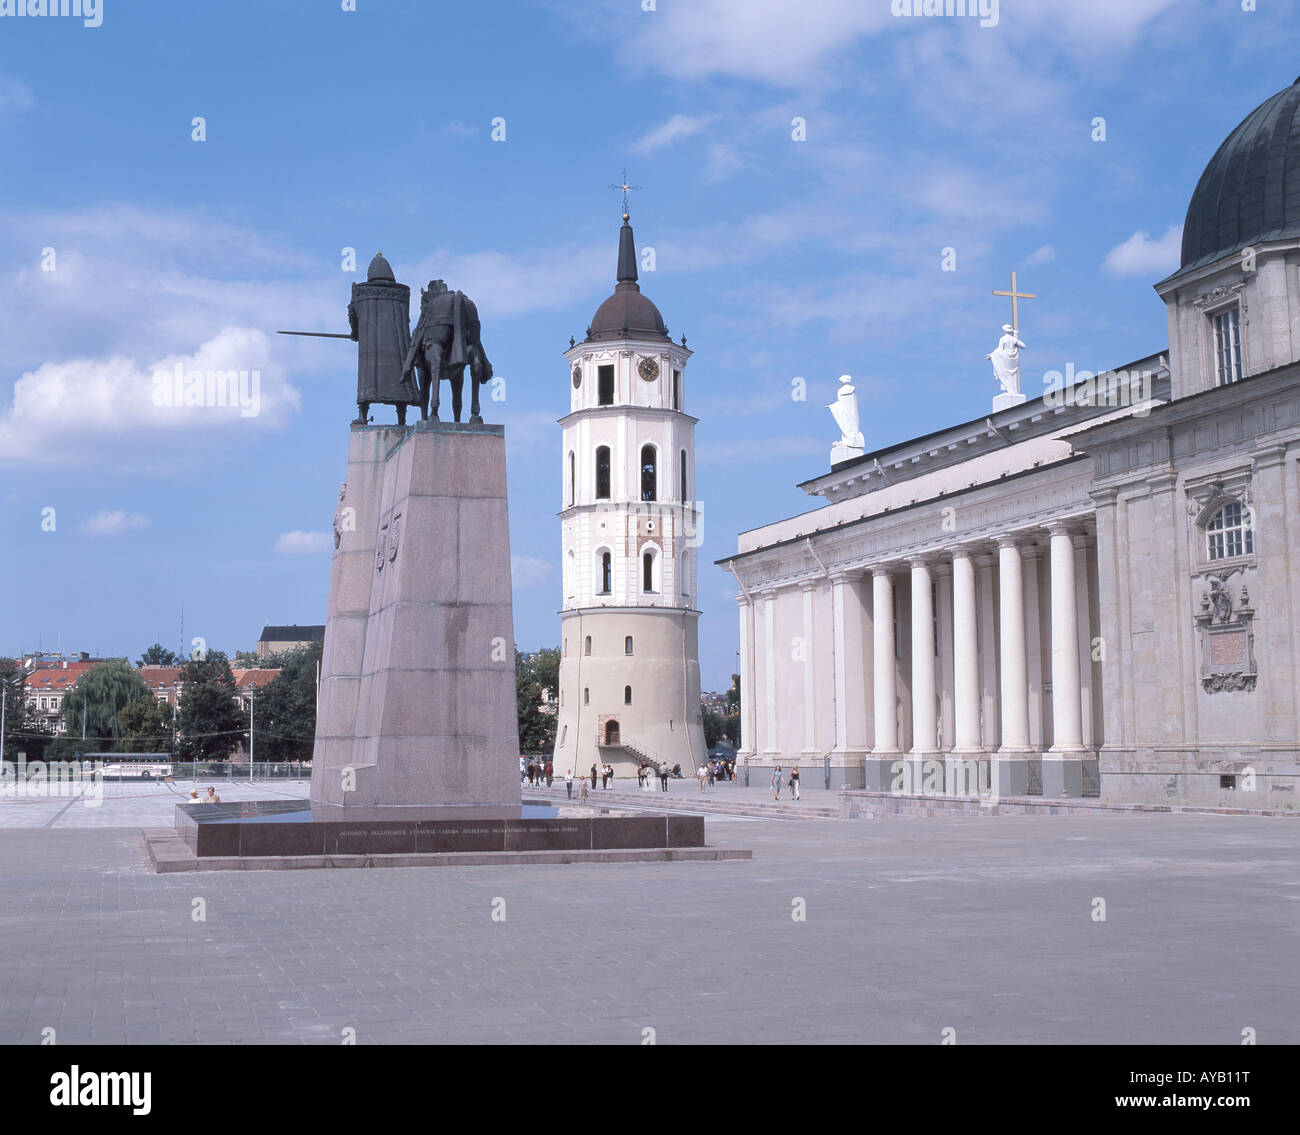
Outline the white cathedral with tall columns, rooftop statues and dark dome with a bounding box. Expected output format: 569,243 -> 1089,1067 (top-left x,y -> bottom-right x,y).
720,81 -> 1300,809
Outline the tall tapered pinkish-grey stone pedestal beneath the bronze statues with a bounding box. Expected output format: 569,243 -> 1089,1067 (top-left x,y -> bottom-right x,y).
311,423 -> 520,819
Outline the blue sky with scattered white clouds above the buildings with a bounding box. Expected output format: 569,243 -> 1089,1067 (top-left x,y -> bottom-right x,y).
0,0 -> 1300,688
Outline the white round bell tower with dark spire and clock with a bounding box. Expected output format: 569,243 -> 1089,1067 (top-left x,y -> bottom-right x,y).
554,213 -> 705,776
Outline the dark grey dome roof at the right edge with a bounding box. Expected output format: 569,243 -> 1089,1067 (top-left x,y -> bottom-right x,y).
1175,79 -> 1300,274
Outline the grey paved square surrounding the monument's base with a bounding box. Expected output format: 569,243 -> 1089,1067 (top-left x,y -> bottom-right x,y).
0,785 -> 1300,1044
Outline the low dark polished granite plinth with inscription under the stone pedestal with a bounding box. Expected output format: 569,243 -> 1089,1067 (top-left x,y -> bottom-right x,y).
176,800 -> 705,858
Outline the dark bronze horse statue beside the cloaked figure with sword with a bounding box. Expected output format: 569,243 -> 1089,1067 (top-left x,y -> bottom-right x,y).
402,280 -> 493,425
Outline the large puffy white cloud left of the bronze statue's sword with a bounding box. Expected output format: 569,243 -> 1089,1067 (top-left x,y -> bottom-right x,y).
0,328 -> 299,465
